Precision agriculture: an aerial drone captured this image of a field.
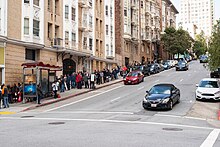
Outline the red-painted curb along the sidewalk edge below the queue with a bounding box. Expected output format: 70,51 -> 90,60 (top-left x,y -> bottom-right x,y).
20,80 -> 123,112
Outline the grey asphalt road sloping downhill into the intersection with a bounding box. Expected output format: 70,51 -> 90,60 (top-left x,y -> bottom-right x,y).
0,61 -> 220,147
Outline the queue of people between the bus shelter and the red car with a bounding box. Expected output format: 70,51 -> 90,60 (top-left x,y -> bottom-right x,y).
52,67 -> 120,98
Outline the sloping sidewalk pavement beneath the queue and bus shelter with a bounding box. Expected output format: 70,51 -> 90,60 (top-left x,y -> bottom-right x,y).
0,77 -> 123,115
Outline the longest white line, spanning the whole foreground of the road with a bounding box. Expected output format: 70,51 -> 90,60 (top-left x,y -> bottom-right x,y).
0,117 -> 215,130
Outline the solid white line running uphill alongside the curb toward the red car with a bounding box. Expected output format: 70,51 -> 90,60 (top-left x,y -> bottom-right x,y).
44,85 -> 124,112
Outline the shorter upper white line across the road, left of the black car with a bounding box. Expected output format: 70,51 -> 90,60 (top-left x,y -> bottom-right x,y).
46,111 -> 134,115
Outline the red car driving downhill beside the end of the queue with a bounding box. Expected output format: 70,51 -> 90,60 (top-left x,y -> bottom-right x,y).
124,71 -> 144,85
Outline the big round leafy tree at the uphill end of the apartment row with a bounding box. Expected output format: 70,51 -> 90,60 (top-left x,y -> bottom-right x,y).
161,27 -> 193,58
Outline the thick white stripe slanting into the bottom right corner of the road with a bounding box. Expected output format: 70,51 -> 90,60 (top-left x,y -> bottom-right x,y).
200,129 -> 220,147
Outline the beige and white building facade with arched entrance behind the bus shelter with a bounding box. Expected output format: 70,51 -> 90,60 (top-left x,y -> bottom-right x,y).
0,0 -> 116,84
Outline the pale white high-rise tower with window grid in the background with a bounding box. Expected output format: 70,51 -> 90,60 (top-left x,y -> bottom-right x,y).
180,0 -> 214,37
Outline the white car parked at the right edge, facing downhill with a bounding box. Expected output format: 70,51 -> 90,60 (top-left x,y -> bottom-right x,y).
196,78 -> 220,100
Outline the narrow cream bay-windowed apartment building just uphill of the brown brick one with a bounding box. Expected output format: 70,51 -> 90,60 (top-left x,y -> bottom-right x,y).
140,0 -> 161,63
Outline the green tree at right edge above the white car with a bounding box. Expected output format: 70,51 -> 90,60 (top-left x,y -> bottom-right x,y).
208,20 -> 220,70
